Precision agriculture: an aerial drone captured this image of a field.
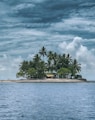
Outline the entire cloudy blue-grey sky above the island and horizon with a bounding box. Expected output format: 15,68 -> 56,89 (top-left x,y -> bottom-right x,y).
0,0 -> 95,80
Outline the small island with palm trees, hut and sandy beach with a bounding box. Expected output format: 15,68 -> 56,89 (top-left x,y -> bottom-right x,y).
15,46 -> 86,82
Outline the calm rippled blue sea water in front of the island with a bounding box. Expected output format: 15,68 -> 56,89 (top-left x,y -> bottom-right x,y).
0,83 -> 95,120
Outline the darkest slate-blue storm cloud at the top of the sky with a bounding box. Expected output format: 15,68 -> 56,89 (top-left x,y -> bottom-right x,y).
7,0 -> 80,24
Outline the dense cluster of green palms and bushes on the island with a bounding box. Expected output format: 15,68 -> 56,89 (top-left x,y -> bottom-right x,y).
17,47 -> 81,79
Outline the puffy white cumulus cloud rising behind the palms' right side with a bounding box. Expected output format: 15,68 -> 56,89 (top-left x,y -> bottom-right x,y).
59,37 -> 95,79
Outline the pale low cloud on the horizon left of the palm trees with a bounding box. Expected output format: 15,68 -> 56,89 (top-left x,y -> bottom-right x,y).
0,54 -> 23,80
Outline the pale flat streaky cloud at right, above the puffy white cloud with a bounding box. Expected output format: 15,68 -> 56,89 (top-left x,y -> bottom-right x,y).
51,17 -> 95,32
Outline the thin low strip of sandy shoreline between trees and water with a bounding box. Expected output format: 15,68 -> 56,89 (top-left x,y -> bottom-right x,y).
0,79 -> 90,83
